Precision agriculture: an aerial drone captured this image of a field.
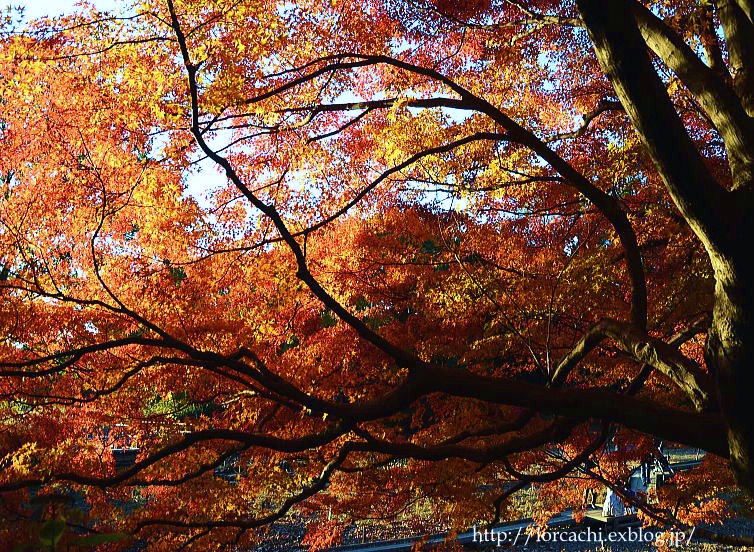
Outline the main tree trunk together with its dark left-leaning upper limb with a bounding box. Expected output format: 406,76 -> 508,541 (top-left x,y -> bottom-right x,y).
577,0 -> 754,495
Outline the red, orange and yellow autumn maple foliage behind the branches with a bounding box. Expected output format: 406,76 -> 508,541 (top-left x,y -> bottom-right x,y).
0,0 -> 730,550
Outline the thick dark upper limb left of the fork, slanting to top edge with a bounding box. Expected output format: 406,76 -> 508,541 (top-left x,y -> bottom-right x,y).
577,0 -> 742,269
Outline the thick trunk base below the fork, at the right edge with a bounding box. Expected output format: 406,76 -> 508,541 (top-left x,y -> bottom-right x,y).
706,264 -> 754,494
